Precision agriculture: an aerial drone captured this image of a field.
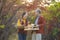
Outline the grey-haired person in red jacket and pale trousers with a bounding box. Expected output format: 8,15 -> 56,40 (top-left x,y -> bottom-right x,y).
32,8 -> 46,40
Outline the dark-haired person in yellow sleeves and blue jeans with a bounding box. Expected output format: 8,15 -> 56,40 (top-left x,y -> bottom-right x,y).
18,12 -> 28,40
